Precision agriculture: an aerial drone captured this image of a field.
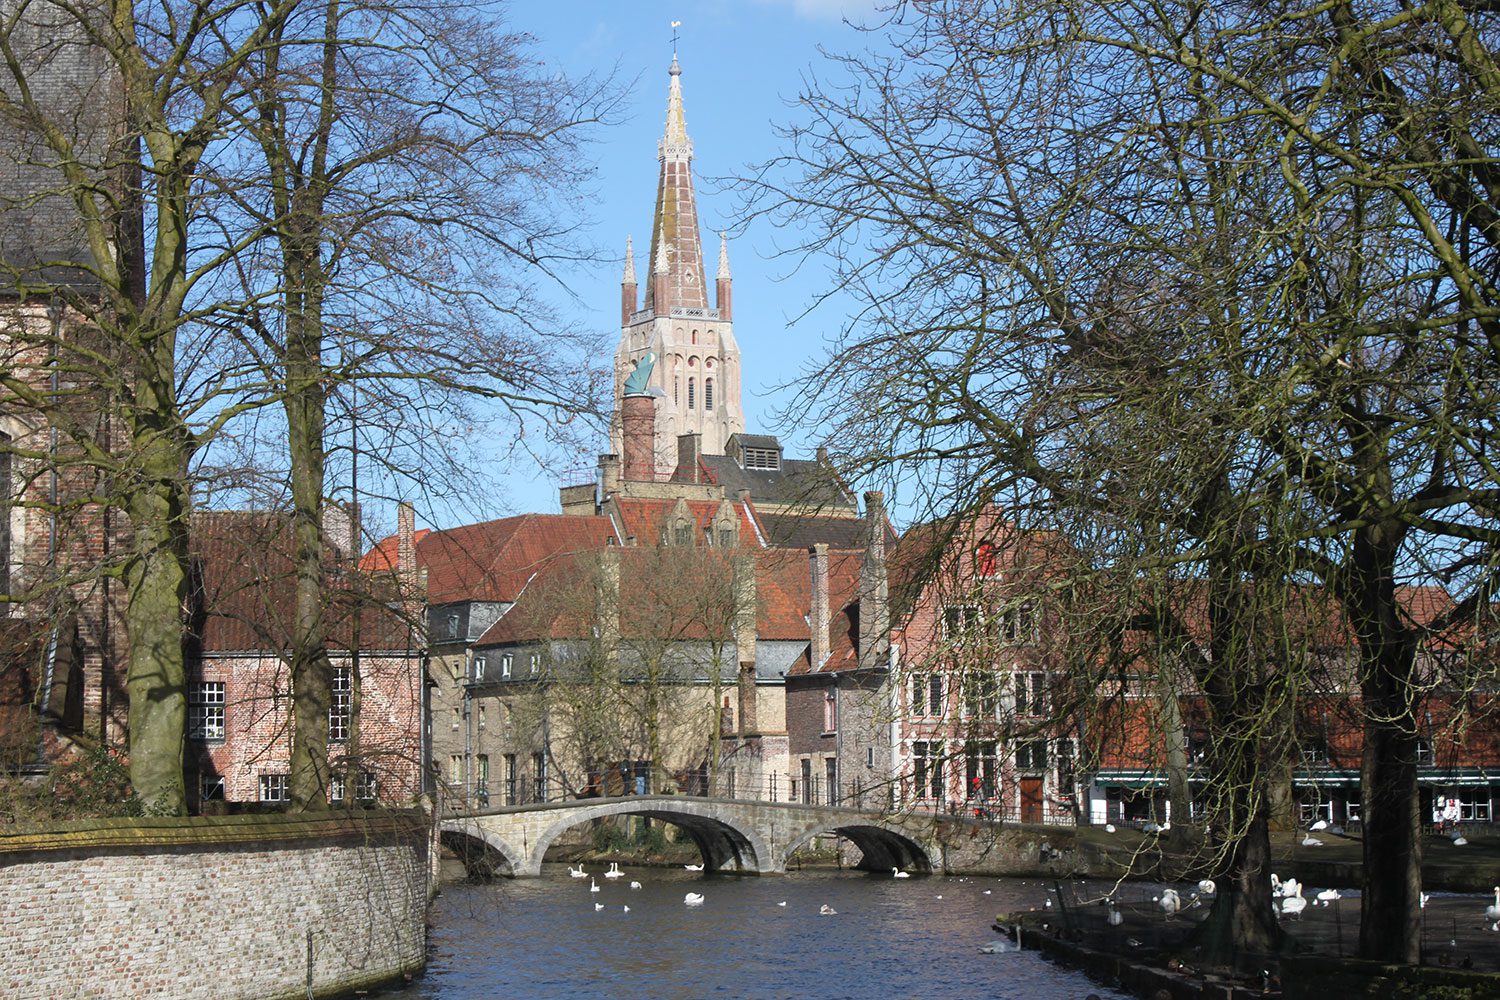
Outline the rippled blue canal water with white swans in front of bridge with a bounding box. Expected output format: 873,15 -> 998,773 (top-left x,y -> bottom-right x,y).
395,864 -> 1125,1000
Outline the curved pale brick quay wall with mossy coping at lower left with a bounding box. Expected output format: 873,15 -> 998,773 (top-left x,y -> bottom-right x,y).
0,811 -> 431,1000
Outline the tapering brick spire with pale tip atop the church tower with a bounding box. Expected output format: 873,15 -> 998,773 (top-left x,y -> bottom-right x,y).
645,55 -> 708,315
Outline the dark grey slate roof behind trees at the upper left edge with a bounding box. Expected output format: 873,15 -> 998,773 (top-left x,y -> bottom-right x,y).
0,4 -> 125,291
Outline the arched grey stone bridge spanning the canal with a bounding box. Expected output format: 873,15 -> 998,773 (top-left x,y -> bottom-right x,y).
440,795 -> 942,877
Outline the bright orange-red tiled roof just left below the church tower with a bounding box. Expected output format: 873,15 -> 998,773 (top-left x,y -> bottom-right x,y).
360,514 -> 615,604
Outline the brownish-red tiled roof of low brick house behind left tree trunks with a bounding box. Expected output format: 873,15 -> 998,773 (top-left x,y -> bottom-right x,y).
189,511 -> 416,654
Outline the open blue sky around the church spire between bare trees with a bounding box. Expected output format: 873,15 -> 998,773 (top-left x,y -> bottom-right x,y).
471,0 -> 875,517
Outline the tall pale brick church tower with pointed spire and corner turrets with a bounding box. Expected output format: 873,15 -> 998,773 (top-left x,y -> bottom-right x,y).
611,54 -> 746,474
